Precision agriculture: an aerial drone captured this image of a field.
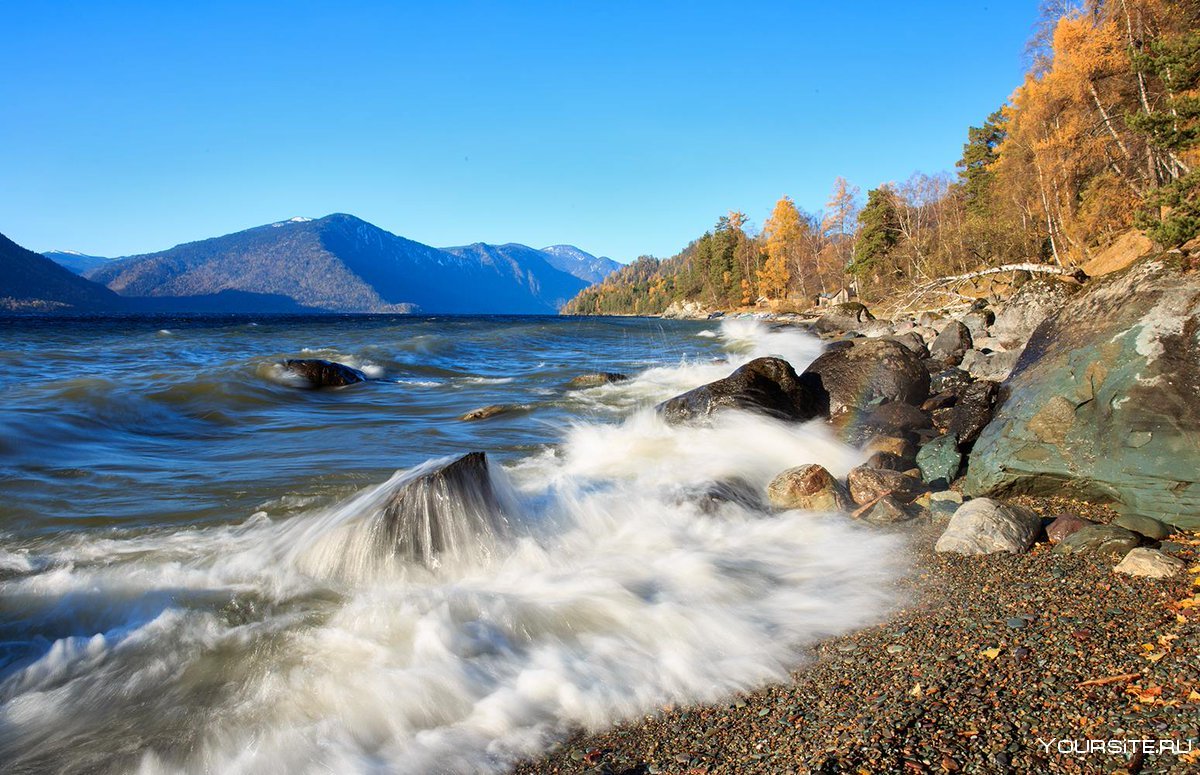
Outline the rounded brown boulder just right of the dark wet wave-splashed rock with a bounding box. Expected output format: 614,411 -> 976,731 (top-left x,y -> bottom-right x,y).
803,340 -> 929,415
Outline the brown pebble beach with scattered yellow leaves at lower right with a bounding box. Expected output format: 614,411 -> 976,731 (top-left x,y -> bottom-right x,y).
511,499 -> 1200,775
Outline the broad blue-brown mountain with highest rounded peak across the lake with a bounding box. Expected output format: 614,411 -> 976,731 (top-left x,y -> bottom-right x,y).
88,214 -> 587,314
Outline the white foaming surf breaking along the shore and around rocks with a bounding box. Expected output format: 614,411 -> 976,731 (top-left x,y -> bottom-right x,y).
0,322 -> 904,773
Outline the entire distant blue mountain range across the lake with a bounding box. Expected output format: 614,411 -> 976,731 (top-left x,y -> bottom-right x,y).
7,214 -> 620,314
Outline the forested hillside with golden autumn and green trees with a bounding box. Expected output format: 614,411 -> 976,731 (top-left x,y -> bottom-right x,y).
564,0 -> 1200,314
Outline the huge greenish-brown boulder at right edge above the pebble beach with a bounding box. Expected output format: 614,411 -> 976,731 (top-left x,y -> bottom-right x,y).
964,260 -> 1200,529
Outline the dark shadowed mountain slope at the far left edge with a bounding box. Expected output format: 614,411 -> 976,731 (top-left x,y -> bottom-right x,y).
0,234 -> 124,313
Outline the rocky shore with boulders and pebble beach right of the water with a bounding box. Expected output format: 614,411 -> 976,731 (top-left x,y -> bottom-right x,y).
516,254 -> 1200,774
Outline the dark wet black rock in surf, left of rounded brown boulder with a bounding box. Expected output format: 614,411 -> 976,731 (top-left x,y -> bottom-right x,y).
658,357 -> 825,423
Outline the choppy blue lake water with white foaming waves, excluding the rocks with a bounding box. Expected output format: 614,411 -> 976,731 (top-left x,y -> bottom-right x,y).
0,317 -> 901,773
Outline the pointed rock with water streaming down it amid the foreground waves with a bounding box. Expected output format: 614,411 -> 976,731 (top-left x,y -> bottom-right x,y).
379,452 -> 509,567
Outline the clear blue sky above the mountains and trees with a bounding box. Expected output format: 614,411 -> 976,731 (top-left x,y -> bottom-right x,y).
0,0 -> 1037,260
